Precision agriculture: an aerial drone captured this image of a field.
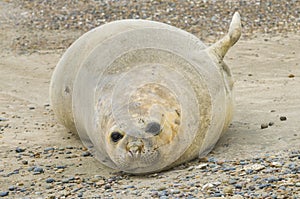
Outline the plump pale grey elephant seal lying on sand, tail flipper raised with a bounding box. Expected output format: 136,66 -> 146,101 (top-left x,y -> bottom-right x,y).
50,13 -> 241,174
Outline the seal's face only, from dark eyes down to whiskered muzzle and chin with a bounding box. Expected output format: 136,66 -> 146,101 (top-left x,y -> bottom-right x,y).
106,111 -> 180,173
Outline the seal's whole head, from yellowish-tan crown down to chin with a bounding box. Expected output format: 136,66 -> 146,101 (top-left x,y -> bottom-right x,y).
105,84 -> 183,173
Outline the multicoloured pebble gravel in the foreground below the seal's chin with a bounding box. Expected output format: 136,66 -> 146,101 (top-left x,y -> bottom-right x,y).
0,146 -> 300,199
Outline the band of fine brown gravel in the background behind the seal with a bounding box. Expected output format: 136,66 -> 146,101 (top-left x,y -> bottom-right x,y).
3,0 -> 300,51
